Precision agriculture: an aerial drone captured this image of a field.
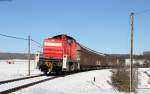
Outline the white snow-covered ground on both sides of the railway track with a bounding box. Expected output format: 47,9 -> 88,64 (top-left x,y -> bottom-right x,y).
0,60 -> 150,94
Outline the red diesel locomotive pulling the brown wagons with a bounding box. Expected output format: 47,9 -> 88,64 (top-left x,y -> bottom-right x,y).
38,34 -> 79,74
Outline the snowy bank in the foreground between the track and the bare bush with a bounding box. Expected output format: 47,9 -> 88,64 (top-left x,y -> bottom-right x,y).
15,69 -> 118,94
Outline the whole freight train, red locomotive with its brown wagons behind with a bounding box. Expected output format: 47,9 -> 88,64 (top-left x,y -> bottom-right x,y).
38,34 -> 117,74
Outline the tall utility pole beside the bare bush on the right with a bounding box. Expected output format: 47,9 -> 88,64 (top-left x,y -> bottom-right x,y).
130,12 -> 134,92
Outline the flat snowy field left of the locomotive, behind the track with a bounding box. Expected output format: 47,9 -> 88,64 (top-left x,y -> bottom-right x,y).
0,60 -> 41,81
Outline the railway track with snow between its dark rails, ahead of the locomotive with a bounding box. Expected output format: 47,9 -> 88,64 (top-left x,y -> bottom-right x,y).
0,75 -> 59,94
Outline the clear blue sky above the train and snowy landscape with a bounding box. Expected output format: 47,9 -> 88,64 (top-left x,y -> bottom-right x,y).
0,0 -> 150,54
